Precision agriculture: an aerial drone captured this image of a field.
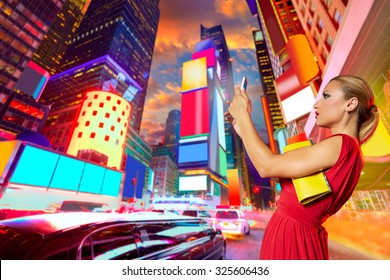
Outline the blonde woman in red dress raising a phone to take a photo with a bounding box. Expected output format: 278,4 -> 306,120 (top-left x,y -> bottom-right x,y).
228,75 -> 379,260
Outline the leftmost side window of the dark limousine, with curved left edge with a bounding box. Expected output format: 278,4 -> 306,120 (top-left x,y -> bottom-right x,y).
81,225 -> 138,260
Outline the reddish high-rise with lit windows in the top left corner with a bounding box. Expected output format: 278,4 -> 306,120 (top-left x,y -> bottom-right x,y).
0,0 -> 65,138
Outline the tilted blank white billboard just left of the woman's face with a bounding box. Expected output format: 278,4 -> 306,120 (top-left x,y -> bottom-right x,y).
282,86 -> 315,123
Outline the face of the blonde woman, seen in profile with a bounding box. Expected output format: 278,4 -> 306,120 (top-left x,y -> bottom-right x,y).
314,81 -> 347,128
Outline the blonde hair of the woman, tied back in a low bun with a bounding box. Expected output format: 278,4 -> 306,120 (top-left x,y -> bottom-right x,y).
330,75 -> 379,144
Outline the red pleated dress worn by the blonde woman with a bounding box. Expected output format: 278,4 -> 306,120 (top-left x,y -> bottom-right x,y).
260,134 -> 363,260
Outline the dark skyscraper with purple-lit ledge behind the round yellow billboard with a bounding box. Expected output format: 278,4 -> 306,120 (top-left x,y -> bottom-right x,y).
42,0 -> 159,150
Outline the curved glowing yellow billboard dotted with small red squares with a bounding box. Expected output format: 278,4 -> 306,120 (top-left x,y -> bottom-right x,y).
67,91 -> 131,169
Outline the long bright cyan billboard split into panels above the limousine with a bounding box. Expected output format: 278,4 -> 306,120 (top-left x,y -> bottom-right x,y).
9,145 -> 123,196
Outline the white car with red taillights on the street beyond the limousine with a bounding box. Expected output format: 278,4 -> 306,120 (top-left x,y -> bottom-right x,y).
213,209 -> 251,238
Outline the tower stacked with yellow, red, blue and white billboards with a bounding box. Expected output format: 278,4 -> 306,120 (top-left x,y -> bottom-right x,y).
178,40 -> 228,206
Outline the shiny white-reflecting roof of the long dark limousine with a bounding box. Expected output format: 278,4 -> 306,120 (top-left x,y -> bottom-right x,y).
0,212 -> 204,235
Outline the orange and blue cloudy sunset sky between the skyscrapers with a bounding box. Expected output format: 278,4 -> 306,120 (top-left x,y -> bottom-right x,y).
140,0 -> 266,145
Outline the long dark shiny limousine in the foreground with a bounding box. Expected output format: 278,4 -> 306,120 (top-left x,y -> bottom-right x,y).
0,212 -> 226,260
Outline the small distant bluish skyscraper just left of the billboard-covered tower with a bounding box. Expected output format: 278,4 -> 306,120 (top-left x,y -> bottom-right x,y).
164,110 -> 180,164
